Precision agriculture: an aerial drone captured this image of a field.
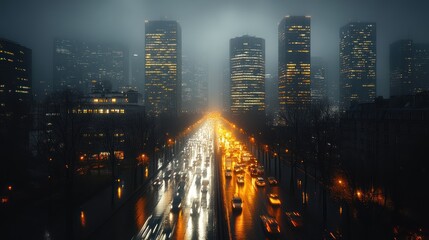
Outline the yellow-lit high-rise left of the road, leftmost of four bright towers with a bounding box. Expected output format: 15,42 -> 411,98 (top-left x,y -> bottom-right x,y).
145,20 -> 182,116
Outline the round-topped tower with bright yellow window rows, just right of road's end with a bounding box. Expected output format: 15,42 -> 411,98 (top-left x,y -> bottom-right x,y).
229,35 -> 265,115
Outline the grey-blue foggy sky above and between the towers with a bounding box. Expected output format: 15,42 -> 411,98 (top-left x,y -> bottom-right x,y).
0,0 -> 429,105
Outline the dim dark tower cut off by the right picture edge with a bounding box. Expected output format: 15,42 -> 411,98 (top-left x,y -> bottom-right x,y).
414,43 -> 429,93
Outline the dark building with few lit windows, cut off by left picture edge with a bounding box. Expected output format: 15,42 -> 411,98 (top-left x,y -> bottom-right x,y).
0,38 -> 33,184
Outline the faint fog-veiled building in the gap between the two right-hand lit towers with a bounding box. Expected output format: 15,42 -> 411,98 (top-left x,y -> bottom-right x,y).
311,58 -> 328,102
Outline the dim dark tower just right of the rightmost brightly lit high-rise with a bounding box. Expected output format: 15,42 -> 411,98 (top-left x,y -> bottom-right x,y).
390,39 -> 416,96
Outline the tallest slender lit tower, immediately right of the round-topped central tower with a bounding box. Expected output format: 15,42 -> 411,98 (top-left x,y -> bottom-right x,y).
278,16 -> 311,112
